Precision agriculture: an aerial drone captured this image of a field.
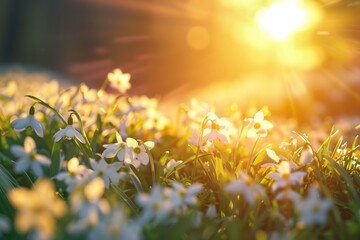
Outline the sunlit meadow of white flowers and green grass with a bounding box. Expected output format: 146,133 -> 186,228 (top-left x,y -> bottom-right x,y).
0,69 -> 360,240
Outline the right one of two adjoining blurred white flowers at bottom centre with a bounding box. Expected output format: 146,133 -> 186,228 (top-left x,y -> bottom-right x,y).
168,181 -> 202,208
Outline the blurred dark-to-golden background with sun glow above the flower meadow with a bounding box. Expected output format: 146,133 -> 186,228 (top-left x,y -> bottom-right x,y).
0,0 -> 360,119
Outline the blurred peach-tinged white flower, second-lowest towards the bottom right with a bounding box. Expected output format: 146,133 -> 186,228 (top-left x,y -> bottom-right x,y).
225,173 -> 265,206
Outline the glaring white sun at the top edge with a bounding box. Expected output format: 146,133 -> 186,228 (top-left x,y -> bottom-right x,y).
256,0 -> 314,40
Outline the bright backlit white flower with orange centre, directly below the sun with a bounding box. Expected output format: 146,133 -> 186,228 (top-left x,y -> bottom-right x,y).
245,110 -> 273,138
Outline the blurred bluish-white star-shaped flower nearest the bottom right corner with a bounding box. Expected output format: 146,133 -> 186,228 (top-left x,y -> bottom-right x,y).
295,186 -> 332,226
